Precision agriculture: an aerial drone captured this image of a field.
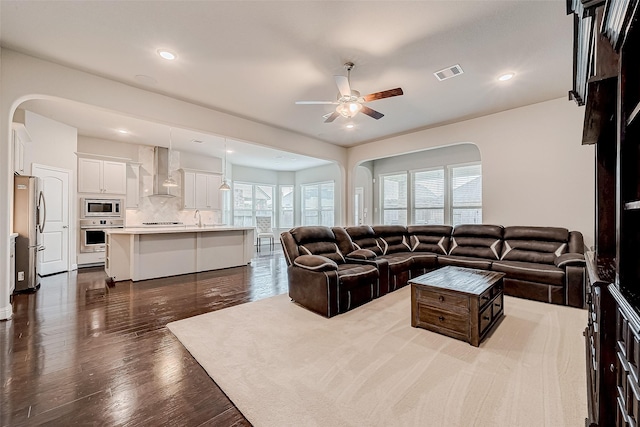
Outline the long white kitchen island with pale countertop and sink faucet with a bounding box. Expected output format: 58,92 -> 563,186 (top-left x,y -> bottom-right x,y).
105,225 -> 255,282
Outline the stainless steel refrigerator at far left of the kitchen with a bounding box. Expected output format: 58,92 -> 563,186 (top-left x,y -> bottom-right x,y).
13,175 -> 47,292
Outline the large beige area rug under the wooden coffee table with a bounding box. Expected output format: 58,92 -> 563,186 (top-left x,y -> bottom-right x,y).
168,287 -> 587,427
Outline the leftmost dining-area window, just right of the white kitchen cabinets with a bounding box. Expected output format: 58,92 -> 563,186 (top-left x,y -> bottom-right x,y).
233,182 -> 274,227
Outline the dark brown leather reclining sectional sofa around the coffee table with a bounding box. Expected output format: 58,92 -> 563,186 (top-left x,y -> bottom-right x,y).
280,224 -> 585,317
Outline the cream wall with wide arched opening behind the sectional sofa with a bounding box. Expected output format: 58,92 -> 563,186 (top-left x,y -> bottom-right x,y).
347,98 -> 595,245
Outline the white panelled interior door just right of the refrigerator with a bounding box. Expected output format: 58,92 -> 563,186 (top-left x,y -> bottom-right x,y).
31,164 -> 71,276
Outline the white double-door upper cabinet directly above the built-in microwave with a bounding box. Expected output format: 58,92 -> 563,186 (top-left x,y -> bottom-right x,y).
78,157 -> 127,194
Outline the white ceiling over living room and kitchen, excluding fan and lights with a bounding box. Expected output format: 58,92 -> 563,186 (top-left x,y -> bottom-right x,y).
0,0 -> 573,170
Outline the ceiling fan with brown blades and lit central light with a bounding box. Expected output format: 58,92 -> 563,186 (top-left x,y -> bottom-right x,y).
296,62 -> 403,123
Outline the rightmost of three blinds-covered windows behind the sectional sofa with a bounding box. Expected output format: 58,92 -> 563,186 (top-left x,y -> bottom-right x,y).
451,164 -> 482,226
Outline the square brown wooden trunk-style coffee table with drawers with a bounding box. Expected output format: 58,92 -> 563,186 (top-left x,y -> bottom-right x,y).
409,266 -> 504,347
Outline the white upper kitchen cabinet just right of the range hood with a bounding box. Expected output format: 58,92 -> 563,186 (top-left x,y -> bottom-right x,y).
182,170 -> 222,210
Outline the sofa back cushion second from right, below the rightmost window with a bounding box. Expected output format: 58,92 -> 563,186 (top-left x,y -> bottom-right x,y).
449,224 -> 503,260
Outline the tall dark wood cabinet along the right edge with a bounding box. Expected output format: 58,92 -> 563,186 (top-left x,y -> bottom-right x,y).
567,0 -> 640,427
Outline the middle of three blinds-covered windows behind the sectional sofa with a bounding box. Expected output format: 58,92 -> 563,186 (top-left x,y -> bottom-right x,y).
411,169 -> 445,224
